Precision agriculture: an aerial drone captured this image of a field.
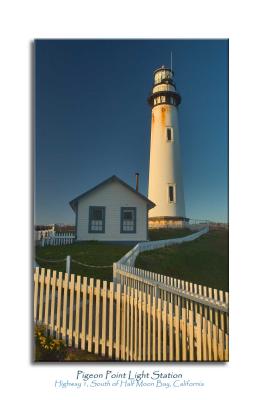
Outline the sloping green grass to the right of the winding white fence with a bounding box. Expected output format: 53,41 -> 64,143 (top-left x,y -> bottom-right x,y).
136,230 -> 229,291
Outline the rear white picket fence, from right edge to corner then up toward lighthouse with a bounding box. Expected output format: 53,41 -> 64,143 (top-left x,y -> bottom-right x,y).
113,226 -> 229,333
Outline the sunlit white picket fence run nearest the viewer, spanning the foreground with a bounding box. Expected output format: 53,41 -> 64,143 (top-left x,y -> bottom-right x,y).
34,267 -> 228,361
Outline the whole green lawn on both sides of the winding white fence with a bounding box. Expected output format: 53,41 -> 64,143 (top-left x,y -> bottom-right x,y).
36,229 -> 228,290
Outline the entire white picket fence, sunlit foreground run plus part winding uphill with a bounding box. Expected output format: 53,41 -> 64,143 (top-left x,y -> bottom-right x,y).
34,223 -> 229,361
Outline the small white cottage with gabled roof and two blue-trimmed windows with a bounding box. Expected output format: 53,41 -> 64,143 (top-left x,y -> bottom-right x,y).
69,175 -> 155,242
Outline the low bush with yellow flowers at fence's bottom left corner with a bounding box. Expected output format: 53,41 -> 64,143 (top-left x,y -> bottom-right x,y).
35,325 -> 68,361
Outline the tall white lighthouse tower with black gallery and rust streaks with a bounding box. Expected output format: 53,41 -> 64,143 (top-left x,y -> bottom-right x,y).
148,66 -> 189,228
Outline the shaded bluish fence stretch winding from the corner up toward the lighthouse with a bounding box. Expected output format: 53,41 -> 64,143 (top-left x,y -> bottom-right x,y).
115,226 -> 209,267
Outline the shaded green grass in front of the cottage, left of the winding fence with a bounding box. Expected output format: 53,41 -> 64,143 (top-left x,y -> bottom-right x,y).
35,242 -> 133,281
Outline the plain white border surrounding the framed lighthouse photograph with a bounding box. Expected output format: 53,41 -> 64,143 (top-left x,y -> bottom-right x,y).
0,0 -> 263,400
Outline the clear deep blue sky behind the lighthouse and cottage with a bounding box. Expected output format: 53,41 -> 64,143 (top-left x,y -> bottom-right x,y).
35,40 -> 228,224
